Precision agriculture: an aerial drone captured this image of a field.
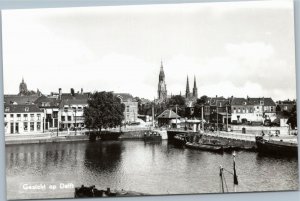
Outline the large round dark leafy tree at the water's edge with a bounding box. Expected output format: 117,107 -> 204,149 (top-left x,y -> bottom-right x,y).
84,91 -> 125,132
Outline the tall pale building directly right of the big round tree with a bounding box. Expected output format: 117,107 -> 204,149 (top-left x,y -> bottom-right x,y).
115,93 -> 138,124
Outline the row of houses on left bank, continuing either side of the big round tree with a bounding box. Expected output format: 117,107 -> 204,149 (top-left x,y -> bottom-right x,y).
4,89 -> 138,134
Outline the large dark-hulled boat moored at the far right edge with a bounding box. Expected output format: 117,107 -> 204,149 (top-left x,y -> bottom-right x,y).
255,136 -> 298,156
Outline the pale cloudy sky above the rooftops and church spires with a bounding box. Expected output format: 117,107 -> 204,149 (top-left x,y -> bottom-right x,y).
2,0 -> 296,100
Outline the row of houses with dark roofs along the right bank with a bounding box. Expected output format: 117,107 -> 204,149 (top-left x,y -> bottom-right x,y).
188,96 -> 296,124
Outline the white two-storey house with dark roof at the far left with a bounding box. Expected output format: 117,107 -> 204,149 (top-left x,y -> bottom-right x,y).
4,104 -> 44,134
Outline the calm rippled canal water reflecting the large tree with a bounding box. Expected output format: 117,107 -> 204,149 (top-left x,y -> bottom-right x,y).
6,140 -> 299,199
